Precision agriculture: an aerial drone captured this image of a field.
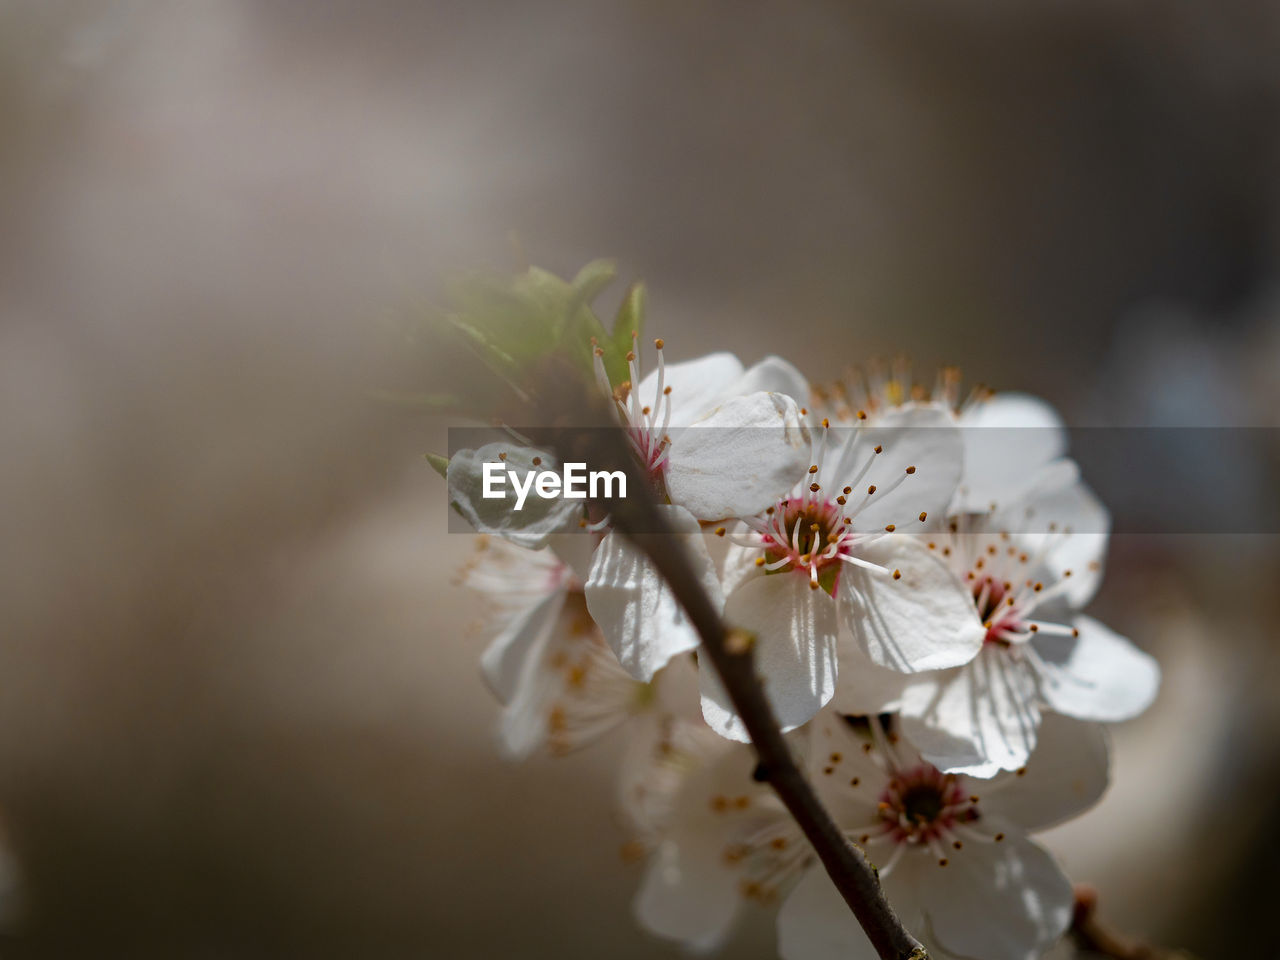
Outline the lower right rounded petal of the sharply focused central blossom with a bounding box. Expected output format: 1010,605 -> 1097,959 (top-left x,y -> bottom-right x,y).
837,535 -> 986,673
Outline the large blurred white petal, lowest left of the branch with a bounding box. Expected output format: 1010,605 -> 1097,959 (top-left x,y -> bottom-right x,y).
634,746 -> 757,950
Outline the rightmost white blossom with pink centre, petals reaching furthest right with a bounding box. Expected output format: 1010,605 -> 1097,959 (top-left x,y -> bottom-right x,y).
899,478 -> 1160,777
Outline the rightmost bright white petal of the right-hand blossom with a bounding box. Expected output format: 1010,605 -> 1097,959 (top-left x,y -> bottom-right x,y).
1032,617 -> 1160,722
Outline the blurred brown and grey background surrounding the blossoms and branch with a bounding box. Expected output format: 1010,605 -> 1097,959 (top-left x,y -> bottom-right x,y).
0,0 -> 1280,960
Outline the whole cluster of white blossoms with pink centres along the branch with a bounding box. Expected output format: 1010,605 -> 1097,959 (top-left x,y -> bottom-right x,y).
448,340 -> 1158,960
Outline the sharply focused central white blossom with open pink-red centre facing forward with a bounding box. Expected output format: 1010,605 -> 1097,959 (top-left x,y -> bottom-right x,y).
703,404 -> 983,740
